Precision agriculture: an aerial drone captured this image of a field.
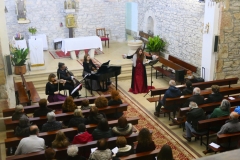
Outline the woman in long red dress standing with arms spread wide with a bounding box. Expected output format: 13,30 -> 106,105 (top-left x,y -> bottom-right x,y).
123,48 -> 158,94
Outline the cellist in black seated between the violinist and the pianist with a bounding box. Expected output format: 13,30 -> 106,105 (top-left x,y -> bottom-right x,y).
57,62 -> 80,98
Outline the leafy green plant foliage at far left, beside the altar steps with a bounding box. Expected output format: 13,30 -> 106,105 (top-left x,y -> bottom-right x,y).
11,48 -> 29,66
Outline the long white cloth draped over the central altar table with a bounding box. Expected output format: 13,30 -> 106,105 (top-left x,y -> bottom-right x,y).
62,36 -> 102,54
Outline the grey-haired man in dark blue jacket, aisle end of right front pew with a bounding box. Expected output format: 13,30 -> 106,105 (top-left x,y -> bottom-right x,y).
154,80 -> 181,117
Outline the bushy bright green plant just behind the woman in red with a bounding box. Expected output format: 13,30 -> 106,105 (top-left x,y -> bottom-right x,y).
146,36 -> 166,55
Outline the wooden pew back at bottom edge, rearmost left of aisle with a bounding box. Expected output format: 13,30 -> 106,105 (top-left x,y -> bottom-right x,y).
120,149 -> 161,160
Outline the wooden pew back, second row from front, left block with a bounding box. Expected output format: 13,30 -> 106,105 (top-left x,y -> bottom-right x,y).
4,103 -> 128,130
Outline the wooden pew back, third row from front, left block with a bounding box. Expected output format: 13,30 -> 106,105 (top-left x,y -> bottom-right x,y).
5,117 -> 139,148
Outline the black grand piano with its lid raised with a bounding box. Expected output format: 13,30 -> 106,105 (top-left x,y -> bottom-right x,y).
86,61 -> 121,94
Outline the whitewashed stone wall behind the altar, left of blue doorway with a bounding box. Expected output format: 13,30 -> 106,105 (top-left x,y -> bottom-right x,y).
5,0 -> 125,49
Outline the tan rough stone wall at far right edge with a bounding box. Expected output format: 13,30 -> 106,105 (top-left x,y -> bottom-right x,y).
216,0 -> 240,79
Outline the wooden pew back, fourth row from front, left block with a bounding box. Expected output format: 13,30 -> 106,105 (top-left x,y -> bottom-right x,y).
6,133 -> 138,160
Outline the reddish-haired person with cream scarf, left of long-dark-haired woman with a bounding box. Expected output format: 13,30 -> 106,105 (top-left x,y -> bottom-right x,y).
115,136 -> 134,157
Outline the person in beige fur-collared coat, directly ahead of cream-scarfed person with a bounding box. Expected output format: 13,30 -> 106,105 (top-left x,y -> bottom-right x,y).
112,116 -> 133,136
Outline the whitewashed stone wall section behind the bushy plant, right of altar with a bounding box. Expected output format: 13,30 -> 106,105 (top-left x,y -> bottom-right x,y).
134,0 -> 204,72
